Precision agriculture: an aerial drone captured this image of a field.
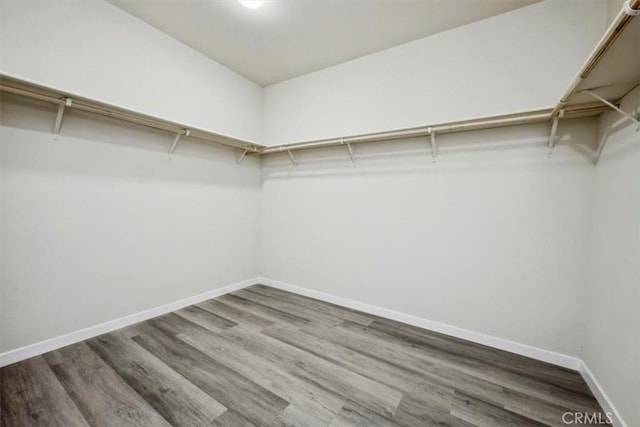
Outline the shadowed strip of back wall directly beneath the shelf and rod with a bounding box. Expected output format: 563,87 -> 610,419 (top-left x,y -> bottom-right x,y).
263,118 -> 598,178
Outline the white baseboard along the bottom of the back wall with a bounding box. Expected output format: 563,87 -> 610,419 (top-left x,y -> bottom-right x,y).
258,277 -> 581,371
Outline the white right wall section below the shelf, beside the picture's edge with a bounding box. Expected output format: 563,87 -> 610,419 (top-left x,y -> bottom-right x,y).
582,88 -> 640,426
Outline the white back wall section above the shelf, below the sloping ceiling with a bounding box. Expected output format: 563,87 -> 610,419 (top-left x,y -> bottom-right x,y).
263,0 -> 607,145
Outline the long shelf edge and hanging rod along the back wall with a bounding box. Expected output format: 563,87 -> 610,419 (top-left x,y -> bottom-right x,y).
260,104 -> 609,154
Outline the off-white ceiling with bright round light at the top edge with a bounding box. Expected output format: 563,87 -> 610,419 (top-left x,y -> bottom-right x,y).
108,0 -> 540,86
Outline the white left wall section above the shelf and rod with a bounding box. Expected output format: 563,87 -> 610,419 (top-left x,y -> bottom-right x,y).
0,0 -> 262,142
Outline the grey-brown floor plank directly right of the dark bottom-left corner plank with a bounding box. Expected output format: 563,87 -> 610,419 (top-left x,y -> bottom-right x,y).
44,342 -> 170,426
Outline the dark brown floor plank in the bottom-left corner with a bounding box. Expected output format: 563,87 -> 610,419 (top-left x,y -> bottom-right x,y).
0,356 -> 89,427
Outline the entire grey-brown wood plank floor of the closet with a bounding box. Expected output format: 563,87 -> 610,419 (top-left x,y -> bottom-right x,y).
0,285 -> 606,427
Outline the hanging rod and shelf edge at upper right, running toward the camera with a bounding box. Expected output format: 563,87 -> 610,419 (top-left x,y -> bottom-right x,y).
551,0 -> 640,117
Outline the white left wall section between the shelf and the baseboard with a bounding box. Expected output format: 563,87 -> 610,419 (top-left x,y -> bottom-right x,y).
0,97 -> 260,352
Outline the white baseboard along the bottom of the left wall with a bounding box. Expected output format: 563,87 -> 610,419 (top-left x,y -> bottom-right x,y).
0,277 -> 259,367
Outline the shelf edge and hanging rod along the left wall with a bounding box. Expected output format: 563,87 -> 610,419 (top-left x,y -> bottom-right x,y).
0,79 -> 264,153
